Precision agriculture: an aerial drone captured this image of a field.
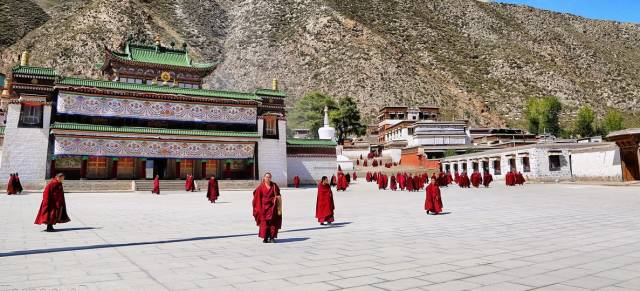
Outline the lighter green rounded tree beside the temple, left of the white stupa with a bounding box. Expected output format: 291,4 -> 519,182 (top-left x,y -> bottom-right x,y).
289,92 -> 336,138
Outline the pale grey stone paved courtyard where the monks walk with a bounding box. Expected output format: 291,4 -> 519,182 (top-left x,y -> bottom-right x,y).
0,181 -> 640,291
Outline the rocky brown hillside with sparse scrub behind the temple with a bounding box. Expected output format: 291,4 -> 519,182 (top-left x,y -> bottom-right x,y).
0,0 -> 640,125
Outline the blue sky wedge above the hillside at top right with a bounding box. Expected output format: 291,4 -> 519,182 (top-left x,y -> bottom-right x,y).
498,0 -> 640,23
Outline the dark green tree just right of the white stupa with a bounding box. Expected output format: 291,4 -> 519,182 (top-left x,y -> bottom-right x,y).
331,96 -> 366,144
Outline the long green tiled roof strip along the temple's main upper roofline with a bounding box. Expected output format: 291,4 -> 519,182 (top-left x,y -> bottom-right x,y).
58,78 -> 262,101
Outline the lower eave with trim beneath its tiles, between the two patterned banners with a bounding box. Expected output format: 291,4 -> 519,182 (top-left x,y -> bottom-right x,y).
51,122 -> 260,140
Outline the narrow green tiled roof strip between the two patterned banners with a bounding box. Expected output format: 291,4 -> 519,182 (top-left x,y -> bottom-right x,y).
51,122 -> 260,137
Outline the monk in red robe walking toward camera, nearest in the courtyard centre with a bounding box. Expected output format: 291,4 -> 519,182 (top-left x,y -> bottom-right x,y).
253,172 -> 282,243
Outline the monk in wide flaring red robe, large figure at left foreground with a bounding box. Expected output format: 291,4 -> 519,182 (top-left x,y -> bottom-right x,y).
34,173 -> 71,232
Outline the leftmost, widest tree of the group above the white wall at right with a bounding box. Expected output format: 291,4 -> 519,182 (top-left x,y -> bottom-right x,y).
525,96 -> 562,136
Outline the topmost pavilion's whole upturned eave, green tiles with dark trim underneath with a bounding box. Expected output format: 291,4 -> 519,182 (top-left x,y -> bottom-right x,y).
99,43 -> 217,76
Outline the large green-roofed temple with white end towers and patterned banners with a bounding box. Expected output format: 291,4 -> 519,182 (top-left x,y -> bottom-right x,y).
0,40 -> 335,184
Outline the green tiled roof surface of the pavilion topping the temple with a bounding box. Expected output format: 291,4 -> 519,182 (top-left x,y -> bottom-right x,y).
111,43 -> 214,69
